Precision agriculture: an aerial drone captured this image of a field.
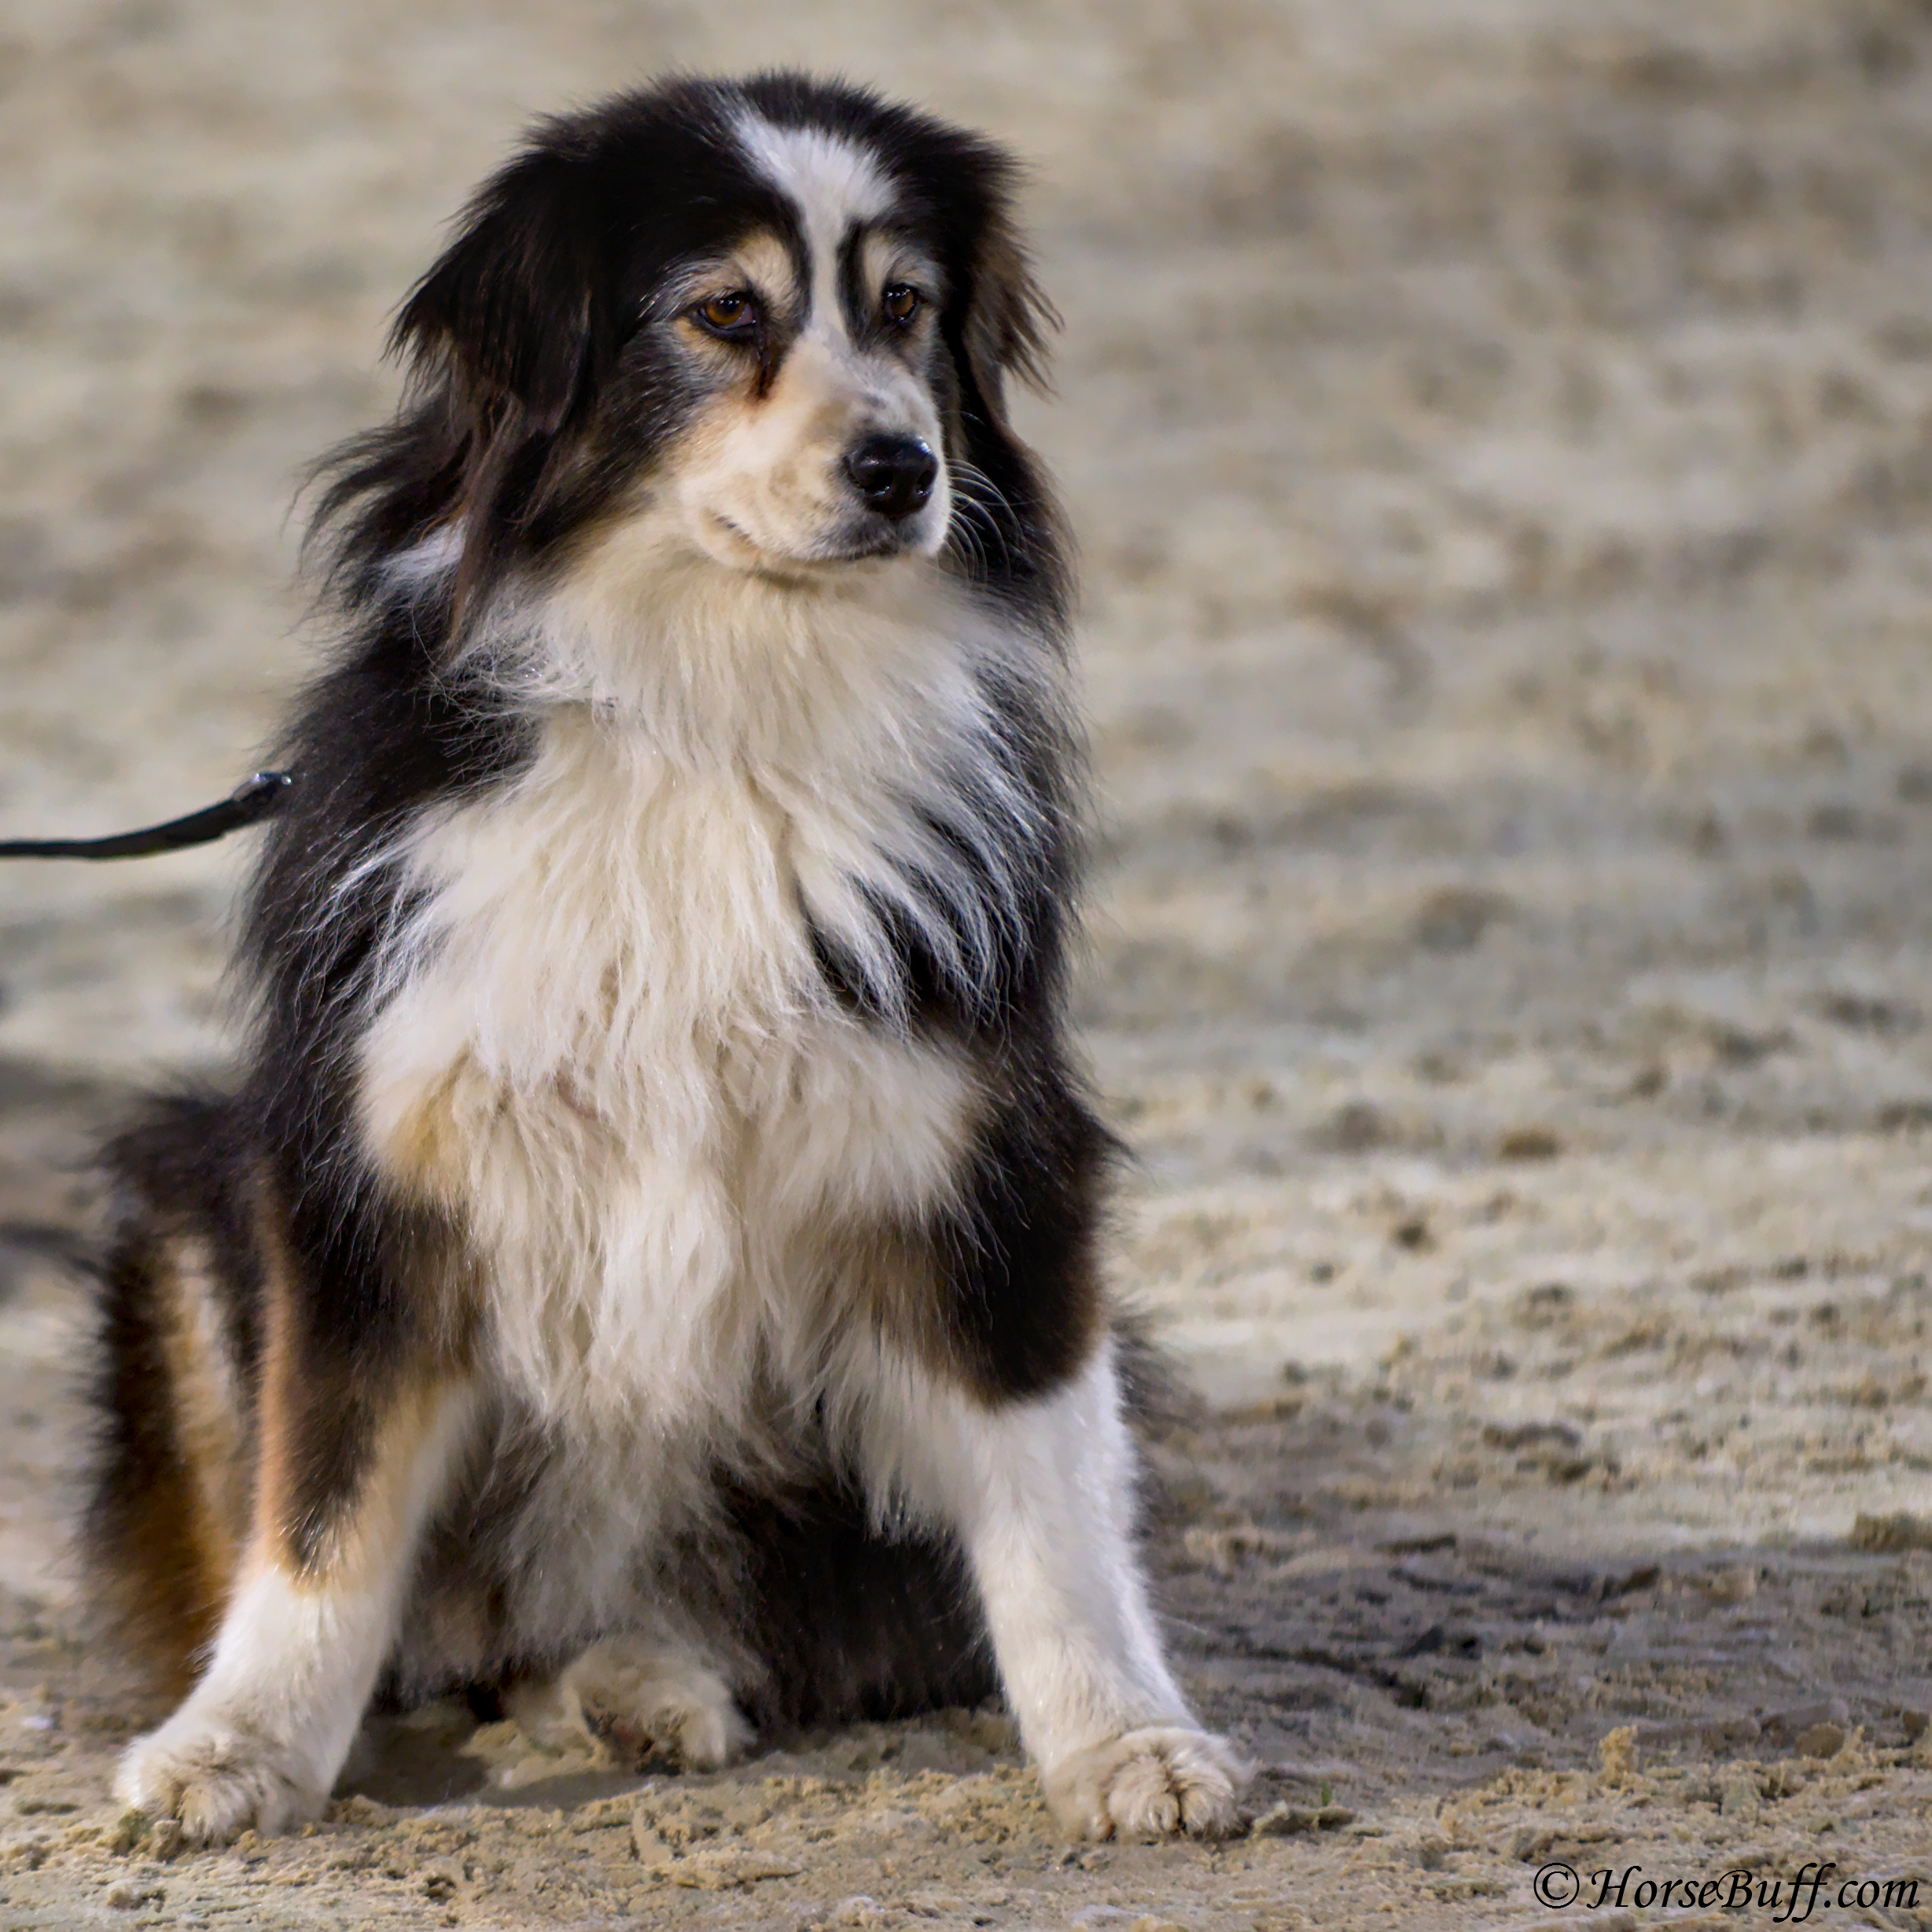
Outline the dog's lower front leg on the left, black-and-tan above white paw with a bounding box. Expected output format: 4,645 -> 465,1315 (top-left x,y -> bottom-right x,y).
114,1331 -> 475,1843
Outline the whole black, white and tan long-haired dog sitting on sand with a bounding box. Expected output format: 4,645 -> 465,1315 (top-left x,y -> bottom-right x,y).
87,73 -> 1242,1839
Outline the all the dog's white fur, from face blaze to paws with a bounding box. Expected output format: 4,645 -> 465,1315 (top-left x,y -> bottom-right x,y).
118,94 -> 1238,1838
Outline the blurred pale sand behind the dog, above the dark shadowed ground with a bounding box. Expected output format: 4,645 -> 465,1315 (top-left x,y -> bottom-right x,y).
0,0 -> 1932,1529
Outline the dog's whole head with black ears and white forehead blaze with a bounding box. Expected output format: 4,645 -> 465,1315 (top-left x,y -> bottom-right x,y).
355,73 -> 1051,610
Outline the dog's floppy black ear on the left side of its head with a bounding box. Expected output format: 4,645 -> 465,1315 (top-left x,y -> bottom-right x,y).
390,147 -> 599,436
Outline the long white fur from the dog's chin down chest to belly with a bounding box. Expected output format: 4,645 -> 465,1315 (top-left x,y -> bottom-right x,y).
345,539 -> 1051,1639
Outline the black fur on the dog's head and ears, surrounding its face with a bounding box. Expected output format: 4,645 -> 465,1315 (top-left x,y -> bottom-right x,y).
317,73 -> 1066,628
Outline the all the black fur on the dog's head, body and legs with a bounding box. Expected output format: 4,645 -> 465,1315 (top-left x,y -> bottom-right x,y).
90,73 -> 1111,1724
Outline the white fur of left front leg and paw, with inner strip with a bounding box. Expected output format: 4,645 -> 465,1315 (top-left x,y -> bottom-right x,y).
114,1389 -> 475,1842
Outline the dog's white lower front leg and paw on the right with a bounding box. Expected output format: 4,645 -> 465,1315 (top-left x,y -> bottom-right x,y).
885,1345 -> 1248,1838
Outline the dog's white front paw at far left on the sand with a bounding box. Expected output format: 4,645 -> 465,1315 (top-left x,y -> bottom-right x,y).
114,1709 -> 329,1845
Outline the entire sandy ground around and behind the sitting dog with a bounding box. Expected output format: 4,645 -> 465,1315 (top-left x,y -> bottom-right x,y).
0,0 -> 1932,1932
